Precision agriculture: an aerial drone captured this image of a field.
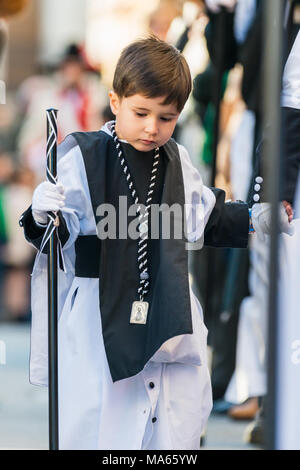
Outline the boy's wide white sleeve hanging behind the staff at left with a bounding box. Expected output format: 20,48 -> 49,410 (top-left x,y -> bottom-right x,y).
30,139 -> 96,385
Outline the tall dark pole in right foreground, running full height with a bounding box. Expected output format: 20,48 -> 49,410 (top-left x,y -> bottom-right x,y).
263,0 -> 284,450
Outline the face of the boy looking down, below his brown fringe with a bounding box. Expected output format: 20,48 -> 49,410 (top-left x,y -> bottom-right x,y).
109,91 -> 180,152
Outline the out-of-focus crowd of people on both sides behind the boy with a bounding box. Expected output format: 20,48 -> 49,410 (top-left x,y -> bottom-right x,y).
0,0 -> 299,448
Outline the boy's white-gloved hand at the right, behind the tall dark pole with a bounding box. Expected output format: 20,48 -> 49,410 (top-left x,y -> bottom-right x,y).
252,202 -> 295,241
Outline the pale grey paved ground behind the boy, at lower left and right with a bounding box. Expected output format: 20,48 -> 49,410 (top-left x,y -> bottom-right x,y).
0,323 -> 260,450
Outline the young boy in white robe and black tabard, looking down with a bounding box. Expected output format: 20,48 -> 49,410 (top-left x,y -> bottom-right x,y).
21,37 -> 290,449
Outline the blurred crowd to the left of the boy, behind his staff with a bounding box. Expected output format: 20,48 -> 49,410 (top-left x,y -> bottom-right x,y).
0,44 -> 111,320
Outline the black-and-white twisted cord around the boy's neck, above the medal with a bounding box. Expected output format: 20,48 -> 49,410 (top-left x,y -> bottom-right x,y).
111,121 -> 159,301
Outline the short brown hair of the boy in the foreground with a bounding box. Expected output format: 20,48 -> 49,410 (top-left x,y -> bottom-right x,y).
113,35 -> 192,112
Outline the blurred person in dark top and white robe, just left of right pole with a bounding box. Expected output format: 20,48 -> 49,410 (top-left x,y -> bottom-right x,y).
200,0 -> 284,419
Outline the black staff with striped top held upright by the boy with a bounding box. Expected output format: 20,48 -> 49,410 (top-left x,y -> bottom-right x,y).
45,108 -> 58,450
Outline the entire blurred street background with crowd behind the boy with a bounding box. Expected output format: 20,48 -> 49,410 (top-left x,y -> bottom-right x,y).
0,0 -> 299,449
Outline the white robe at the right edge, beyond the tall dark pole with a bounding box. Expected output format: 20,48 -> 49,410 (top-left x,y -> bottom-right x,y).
275,178 -> 300,450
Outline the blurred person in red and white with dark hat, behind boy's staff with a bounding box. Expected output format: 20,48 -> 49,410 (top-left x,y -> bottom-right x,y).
18,44 -> 107,179
